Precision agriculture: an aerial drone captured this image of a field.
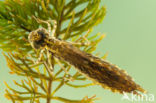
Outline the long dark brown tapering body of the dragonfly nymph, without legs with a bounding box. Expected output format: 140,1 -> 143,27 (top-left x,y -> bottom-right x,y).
29,30 -> 145,93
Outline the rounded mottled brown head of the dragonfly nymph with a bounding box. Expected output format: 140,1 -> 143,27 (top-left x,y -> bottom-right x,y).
28,28 -> 49,49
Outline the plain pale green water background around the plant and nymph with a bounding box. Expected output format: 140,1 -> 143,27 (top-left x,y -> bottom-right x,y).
0,0 -> 156,103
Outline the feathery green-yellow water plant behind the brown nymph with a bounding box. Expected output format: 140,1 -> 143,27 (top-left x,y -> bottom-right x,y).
0,0 -> 106,103
